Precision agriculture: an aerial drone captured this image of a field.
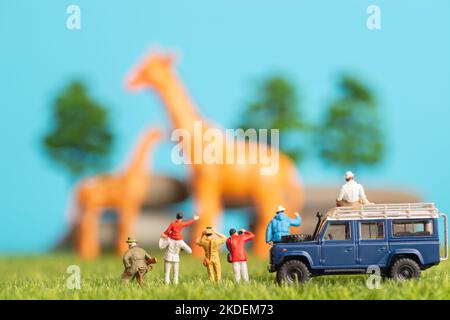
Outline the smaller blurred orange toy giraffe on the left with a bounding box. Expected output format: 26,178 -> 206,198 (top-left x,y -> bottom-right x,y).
76,128 -> 162,259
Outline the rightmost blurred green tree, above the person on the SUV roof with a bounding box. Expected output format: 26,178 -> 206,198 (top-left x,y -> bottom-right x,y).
317,75 -> 385,169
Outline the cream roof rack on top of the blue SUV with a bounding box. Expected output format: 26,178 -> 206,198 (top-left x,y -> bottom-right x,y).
327,203 -> 439,220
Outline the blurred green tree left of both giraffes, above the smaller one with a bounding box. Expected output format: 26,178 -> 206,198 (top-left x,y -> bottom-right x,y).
43,81 -> 113,180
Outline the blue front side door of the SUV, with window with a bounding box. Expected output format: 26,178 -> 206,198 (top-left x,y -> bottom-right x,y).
321,221 -> 356,268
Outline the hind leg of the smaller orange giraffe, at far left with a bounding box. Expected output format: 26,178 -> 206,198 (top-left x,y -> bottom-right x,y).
77,205 -> 101,259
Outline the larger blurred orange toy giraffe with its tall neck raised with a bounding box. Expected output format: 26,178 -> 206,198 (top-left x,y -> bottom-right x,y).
127,53 -> 303,257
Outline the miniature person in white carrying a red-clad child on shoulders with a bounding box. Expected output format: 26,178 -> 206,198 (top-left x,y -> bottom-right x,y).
159,234 -> 192,284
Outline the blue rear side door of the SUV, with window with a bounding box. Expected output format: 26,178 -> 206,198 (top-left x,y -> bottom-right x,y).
358,220 -> 389,266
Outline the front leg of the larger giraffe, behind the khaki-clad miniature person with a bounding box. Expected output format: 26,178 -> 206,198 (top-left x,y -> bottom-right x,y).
191,175 -> 222,257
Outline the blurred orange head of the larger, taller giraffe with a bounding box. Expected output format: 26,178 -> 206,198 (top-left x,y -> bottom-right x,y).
126,52 -> 175,90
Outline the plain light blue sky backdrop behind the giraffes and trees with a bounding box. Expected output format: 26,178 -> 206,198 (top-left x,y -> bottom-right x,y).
0,0 -> 450,253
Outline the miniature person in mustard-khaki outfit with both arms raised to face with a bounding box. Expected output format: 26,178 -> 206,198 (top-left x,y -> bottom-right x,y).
196,227 -> 227,281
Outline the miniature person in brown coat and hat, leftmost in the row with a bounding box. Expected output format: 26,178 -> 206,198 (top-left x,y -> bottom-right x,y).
122,237 -> 158,288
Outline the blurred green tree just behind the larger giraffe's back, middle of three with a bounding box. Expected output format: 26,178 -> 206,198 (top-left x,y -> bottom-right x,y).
238,75 -> 307,162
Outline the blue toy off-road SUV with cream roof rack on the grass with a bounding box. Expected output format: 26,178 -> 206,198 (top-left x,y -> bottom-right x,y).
269,203 -> 448,284
